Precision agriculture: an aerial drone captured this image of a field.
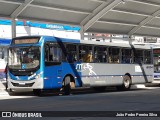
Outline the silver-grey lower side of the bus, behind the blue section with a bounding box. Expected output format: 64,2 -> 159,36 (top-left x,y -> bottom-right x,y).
82,63 -> 153,86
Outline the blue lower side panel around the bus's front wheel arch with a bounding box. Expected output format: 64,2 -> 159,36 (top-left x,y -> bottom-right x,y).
43,62 -> 81,89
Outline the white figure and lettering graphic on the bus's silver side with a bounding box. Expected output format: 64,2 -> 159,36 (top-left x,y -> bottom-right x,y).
76,63 -> 99,79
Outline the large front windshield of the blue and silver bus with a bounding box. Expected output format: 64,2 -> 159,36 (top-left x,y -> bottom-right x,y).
8,46 -> 40,69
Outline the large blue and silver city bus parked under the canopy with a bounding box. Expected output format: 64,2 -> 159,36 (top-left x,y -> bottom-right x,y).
7,36 -> 153,95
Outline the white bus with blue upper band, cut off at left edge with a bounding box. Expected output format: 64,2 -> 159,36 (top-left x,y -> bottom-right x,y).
0,38 -> 11,80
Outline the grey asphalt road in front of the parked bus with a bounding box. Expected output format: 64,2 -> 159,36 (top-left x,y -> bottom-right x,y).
0,87 -> 160,120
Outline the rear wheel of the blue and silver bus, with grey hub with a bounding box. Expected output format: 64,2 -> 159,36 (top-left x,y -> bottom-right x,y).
117,75 -> 131,90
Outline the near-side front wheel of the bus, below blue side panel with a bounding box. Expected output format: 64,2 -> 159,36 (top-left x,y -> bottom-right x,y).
63,76 -> 71,95
